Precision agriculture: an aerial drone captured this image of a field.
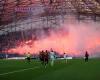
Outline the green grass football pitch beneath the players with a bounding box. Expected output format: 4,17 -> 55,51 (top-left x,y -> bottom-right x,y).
0,59 -> 100,80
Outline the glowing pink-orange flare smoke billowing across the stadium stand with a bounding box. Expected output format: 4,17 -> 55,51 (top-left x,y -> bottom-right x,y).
7,19 -> 100,57
